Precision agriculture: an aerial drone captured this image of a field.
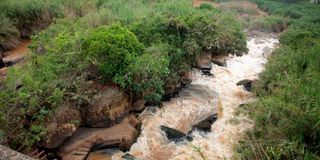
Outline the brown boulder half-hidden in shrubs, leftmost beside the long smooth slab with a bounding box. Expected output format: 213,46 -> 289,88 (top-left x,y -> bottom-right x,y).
41,104 -> 81,149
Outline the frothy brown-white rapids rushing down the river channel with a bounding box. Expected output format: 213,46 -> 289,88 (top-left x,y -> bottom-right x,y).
122,33 -> 279,160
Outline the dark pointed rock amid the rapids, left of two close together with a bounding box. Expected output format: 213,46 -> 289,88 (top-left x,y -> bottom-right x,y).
160,125 -> 192,142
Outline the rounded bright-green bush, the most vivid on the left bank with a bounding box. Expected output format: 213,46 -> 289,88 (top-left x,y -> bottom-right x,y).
82,26 -> 144,81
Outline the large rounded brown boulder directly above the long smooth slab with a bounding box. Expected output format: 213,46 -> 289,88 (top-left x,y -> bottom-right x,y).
85,87 -> 130,127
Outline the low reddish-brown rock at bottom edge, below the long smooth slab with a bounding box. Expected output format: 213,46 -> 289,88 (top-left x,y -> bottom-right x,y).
86,148 -> 121,160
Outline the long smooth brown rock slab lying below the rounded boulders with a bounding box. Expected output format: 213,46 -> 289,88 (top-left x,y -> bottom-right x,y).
59,121 -> 138,160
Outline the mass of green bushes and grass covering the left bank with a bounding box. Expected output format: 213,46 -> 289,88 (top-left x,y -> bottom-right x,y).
0,0 -> 247,155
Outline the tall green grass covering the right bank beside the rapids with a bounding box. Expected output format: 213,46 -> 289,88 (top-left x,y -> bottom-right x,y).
235,0 -> 320,160
